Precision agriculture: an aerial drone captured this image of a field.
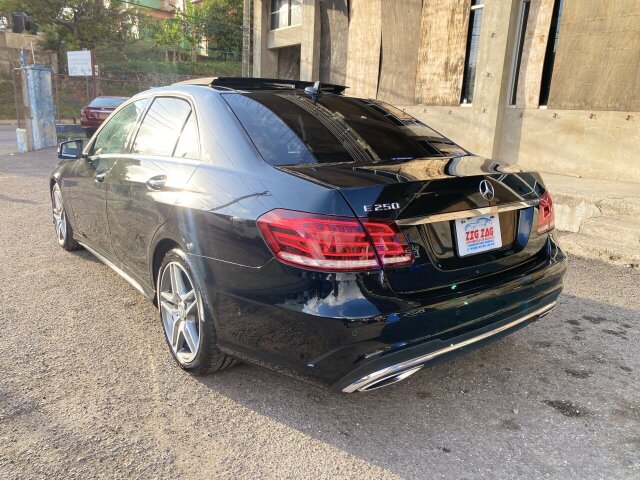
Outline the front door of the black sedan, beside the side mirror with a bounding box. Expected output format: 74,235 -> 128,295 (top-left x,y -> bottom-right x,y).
69,99 -> 147,253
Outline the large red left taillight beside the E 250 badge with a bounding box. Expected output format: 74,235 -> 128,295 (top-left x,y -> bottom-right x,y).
257,209 -> 413,272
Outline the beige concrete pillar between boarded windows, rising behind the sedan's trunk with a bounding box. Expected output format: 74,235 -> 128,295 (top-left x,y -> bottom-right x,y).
470,0 -> 520,158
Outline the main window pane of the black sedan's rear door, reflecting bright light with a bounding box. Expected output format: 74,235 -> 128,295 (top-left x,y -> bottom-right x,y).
131,97 -> 191,157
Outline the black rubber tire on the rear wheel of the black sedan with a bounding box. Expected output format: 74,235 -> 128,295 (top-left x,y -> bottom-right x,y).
156,248 -> 238,376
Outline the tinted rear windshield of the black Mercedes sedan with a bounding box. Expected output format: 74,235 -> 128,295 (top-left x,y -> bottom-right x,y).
223,92 -> 467,165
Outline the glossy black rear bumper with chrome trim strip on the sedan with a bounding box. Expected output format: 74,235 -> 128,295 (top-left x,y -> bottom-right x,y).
202,237 -> 566,392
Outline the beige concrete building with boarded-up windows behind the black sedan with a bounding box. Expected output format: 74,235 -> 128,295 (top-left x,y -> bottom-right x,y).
253,0 -> 640,182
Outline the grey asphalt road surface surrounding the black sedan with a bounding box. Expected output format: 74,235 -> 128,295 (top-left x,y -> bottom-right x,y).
0,149 -> 640,479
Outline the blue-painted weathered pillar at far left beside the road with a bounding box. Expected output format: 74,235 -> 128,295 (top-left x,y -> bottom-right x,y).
20,65 -> 57,151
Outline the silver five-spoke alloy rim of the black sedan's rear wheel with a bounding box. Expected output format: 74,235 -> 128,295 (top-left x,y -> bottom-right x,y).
158,262 -> 202,364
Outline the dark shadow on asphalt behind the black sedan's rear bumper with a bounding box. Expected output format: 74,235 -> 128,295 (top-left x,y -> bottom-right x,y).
192,295 -> 640,477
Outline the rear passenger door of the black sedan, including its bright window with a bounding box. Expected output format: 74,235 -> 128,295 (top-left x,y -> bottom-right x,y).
107,96 -> 199,286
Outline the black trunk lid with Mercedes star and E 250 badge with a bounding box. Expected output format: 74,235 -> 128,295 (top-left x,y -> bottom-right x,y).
279,156 -> 546,293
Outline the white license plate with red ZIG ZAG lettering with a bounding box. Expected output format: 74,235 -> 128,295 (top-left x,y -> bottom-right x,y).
455,213 -> 502,257
